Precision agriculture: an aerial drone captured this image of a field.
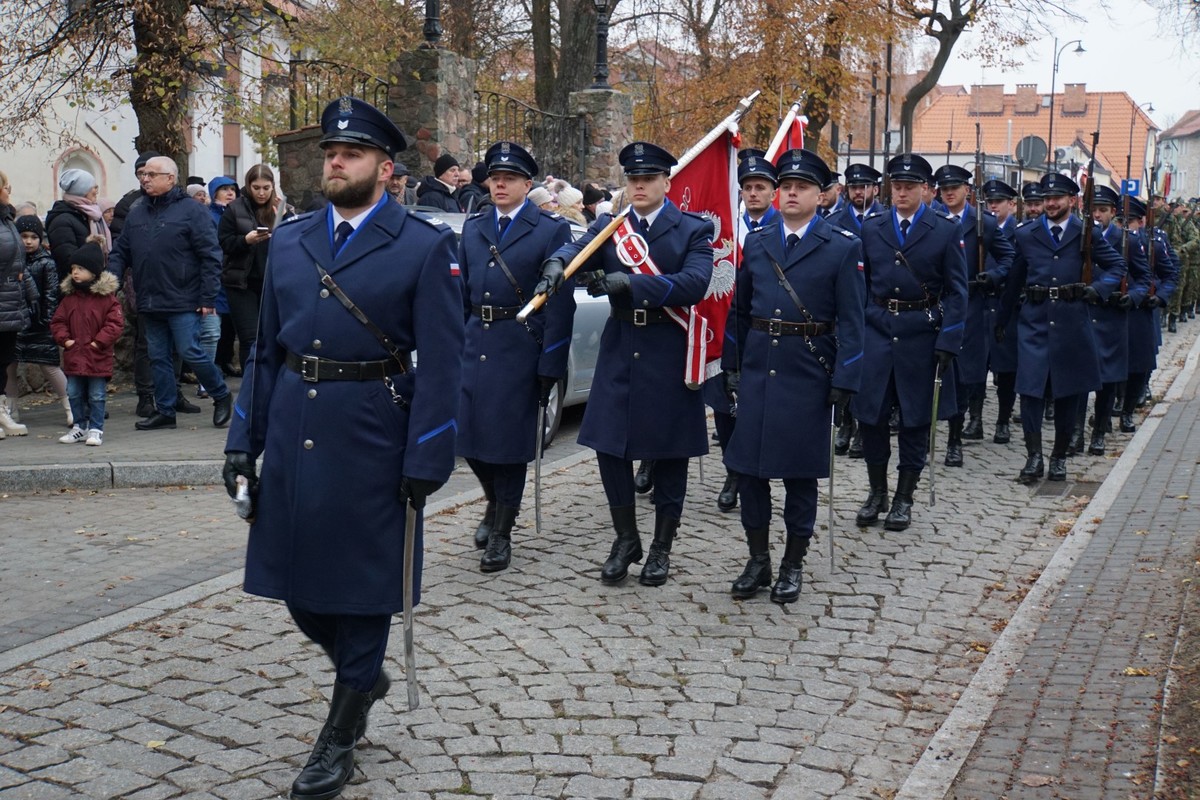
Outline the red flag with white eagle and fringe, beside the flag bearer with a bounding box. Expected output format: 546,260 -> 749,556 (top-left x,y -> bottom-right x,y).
667,130 -> 740,385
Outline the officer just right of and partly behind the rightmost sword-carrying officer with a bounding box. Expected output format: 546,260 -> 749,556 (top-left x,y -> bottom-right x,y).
934,164 -> 1013,467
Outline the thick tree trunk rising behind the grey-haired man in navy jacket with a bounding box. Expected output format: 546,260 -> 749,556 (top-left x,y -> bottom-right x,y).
130,0 -> 191,176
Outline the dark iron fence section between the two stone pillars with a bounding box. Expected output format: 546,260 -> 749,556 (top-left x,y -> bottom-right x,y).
475,91 -> 587,185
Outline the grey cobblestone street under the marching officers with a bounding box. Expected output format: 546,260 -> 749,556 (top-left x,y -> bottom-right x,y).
0,326 -> 1200,800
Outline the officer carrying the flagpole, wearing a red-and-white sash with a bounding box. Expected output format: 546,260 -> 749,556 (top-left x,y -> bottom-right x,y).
542,142 -> 713,585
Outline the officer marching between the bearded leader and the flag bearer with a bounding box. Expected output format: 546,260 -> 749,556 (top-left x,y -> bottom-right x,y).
457,142 -> 575,572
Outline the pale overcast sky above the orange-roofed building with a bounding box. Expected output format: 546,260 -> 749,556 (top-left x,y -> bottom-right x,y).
941,0 -> 1200,130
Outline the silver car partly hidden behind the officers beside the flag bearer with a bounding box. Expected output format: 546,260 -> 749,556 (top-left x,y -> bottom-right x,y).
424,206 -> 608,447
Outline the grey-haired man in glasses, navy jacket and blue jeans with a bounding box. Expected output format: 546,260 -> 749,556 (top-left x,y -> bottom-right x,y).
108,156 -> 233,431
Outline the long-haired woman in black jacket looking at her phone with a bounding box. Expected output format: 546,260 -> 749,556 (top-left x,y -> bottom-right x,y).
217,164 -> 295,371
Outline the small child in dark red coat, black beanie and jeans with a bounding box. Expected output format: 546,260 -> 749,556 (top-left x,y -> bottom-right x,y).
50,241 -> 125,446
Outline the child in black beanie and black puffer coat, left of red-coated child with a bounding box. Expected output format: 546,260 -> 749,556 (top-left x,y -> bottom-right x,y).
8,216 -> 74,425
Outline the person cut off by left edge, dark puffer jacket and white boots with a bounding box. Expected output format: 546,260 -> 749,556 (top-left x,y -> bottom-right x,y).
0,173 -> 37,439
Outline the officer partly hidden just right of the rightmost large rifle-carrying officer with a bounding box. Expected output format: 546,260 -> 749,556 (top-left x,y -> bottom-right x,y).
1075,186 -> 1150,456
